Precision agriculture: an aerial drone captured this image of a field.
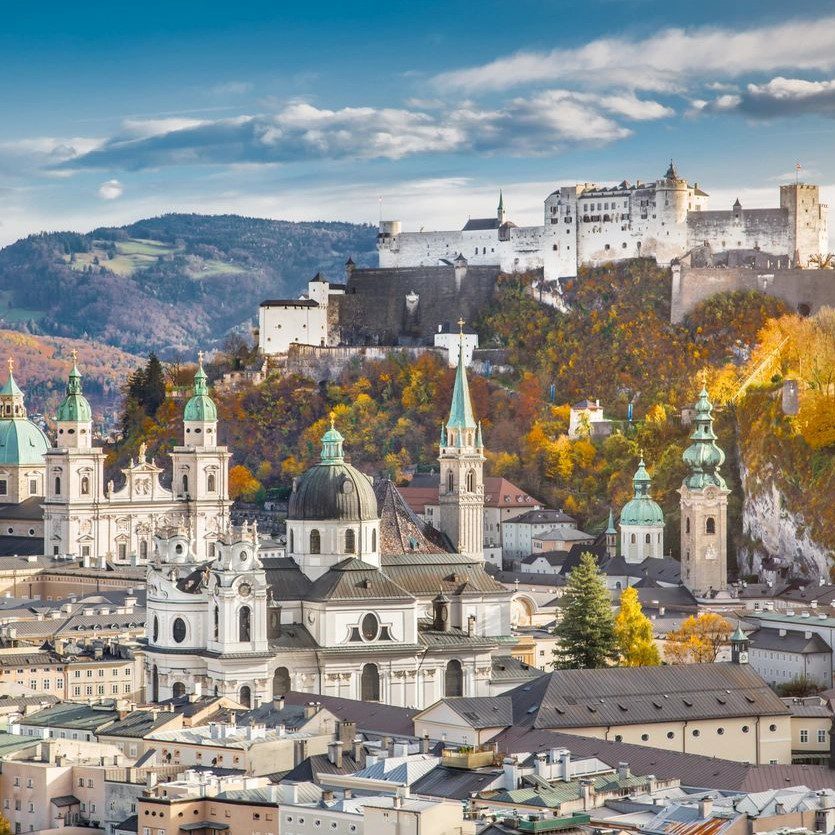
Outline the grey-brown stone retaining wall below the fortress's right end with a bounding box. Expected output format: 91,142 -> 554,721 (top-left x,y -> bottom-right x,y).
670,264 -> 835,323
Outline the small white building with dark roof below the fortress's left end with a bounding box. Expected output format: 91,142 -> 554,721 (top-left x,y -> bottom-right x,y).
258,273 -> 345,355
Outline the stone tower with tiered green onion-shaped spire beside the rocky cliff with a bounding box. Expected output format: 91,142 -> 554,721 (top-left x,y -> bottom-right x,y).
678,385 -> 730,597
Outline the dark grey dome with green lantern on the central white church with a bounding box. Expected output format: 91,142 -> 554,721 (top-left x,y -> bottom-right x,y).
287,420 -> 379,522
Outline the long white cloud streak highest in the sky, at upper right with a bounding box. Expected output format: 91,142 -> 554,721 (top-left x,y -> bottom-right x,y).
435,17 -> 835,92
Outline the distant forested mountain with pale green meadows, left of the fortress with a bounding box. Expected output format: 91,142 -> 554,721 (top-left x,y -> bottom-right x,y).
0,214 -> 377,357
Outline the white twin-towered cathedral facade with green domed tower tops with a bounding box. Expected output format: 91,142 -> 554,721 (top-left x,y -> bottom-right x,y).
43,355 -> 230,566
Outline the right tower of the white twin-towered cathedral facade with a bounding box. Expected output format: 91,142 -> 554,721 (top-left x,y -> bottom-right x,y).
171,353 -> 231,559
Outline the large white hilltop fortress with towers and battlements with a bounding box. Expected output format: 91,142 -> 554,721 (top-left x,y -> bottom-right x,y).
377,162 -> 828,281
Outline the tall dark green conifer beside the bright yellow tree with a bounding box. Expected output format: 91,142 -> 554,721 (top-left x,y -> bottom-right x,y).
554,552 -> 618,670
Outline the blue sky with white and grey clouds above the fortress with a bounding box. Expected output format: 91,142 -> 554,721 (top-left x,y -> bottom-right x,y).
0,0 -> 835,245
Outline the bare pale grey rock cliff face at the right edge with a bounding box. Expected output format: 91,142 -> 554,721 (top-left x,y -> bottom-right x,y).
737,461 -> 835,582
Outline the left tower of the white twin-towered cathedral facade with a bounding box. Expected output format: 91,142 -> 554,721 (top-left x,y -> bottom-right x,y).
44,351 -> 107,561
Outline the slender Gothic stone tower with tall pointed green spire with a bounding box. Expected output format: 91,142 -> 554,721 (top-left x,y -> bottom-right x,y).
438,322 -> 484,560
